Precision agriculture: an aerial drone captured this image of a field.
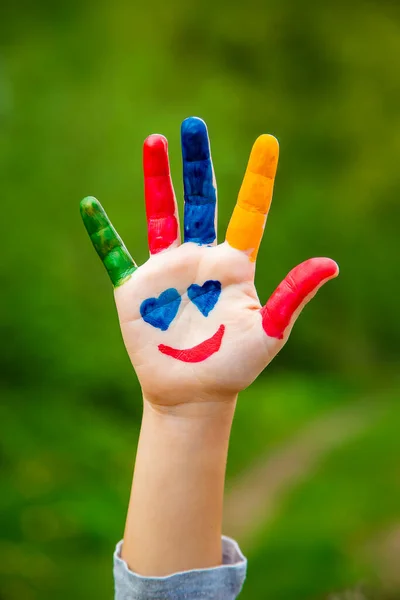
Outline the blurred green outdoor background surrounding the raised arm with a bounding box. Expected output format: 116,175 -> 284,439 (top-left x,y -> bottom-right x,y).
0,0 -> 400,600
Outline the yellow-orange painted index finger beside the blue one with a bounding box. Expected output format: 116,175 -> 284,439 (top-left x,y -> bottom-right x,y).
226,134 -> 279,261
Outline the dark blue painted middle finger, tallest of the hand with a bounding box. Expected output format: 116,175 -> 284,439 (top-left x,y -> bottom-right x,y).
181,117 -> 217,244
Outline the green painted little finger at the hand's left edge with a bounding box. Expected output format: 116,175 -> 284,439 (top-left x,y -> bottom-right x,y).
80,196 -> 137,287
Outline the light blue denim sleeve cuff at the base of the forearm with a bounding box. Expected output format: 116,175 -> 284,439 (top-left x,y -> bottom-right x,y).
114,536 -> 247,600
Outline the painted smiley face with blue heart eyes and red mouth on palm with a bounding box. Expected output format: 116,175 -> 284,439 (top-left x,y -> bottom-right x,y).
140,279 -> 225,363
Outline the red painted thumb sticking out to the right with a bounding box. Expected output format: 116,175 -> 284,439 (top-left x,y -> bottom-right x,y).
260,258 -> 339,340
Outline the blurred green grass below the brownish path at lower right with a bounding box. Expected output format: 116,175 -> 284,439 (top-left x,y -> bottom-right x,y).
243,392 -> 400,600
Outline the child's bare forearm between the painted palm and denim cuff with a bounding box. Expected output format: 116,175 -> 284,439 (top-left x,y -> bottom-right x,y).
122,398 -> 236,576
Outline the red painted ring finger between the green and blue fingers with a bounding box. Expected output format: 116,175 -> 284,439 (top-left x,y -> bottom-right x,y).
143,134 -> 179,254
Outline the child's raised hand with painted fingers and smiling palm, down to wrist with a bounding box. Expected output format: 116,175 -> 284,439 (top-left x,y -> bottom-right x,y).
81,118 -> 338,406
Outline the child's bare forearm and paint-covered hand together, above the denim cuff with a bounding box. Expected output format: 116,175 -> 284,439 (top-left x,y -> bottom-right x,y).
81,118 -> 338,576
